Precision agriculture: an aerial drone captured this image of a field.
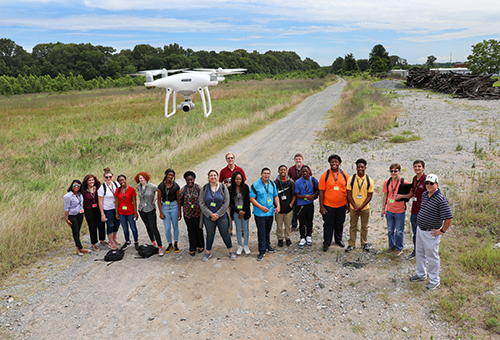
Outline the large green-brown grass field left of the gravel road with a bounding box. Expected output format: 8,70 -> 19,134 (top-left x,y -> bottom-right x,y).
0,78 -> 332,278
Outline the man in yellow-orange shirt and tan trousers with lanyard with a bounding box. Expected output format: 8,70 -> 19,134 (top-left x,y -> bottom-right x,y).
345,158 -> 374,253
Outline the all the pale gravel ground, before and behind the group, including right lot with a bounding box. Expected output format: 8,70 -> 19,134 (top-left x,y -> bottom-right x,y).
0,83 -> 500,339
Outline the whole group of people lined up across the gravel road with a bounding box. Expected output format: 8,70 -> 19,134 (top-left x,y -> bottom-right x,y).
64,153 -> 452,289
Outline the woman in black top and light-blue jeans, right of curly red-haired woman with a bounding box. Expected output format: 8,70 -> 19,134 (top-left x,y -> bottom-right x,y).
158,169 -> 181,254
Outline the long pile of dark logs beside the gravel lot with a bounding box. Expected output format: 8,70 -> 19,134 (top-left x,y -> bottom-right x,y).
406,67 -> 500,99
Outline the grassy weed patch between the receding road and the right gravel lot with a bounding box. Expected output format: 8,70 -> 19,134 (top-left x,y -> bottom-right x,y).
323,80 -> 398,143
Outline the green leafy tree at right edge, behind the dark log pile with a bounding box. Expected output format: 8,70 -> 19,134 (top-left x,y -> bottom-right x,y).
467,39 -> 500,74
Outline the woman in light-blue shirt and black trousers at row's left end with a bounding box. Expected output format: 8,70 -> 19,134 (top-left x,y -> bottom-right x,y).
63,179 -> 90,256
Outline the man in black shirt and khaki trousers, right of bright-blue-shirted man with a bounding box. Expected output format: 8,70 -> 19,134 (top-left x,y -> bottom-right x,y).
274,165 -> 297,247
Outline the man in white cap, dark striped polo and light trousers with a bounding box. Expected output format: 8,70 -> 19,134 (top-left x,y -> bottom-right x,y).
410,174 -> 453,290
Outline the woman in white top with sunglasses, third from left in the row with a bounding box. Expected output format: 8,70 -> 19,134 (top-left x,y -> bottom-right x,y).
97,167 -> 121,249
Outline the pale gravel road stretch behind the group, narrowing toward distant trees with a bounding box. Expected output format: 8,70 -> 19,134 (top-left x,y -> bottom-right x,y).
195,78 -> 345,183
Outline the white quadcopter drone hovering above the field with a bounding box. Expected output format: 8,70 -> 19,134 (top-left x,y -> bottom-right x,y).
131,67 -> 246,118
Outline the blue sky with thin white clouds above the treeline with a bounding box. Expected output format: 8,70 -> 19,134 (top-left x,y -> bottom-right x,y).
0,0 -> 500,67
